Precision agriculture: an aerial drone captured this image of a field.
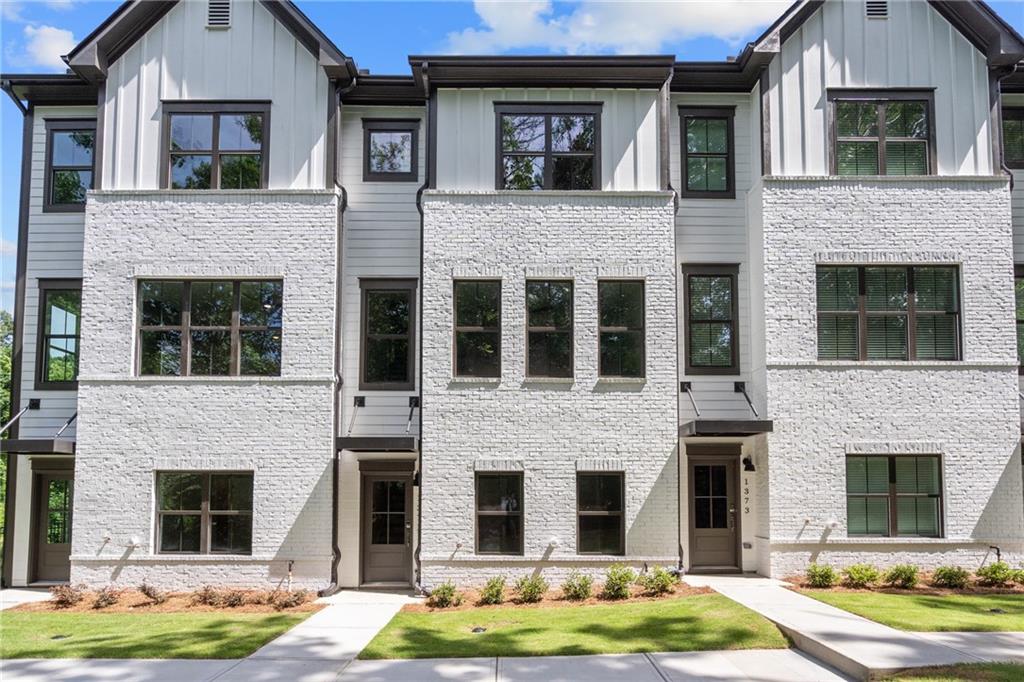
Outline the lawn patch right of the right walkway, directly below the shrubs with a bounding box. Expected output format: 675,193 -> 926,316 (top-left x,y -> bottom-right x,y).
804,590 -> 1024,632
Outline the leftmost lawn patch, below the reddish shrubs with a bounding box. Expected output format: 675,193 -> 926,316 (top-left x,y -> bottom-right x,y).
0,611 -> 311,659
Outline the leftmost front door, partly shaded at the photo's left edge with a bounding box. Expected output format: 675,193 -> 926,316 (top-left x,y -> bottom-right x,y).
35,472 -> 74,582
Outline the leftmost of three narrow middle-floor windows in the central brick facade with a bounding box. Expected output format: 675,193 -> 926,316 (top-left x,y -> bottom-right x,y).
455,280 -> 502,377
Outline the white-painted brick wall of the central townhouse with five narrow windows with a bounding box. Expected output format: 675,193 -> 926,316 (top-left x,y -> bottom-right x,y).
422,191 -> 678,585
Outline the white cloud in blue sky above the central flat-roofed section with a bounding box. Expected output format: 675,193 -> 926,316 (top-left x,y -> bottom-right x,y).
445,0 -> 791,56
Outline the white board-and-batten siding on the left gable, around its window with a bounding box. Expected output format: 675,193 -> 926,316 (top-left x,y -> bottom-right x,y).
103,0 -> 329,189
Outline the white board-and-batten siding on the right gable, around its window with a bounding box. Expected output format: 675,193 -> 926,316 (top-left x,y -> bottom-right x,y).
769,0 -> 992,175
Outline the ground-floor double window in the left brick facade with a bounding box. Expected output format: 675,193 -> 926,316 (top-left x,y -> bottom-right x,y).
157,471 -> 253,554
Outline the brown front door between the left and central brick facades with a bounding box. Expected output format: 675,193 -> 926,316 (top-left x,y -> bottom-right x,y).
362,474 -> 413,584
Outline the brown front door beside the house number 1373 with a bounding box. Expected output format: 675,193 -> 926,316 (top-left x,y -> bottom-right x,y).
689,458 -> 739,570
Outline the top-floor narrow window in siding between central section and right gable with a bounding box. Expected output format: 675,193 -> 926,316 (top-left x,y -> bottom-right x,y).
679,106 -> 736,199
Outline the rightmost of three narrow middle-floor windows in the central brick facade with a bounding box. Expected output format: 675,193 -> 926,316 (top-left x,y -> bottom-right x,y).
597,280 -> 644,377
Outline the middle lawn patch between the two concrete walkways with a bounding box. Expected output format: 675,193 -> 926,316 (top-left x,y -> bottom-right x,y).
359,594 -> 787,658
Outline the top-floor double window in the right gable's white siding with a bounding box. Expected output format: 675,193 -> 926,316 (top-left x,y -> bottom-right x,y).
828,90 -> 935,175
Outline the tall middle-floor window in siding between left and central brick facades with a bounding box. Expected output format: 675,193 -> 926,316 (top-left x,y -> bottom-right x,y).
359,280 -> 416,390
